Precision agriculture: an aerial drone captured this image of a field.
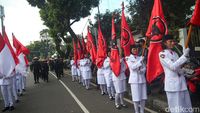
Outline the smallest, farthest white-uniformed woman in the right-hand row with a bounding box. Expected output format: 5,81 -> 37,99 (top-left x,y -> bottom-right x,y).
70,57 -> 77,81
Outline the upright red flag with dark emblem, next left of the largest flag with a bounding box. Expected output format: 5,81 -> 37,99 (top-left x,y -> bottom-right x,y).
120,2 -> 134,56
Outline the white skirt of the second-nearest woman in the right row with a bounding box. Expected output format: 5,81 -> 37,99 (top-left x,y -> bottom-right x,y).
130,83 -> 147,102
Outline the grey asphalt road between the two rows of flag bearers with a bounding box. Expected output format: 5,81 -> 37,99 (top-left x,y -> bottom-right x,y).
0,72 -> 156,113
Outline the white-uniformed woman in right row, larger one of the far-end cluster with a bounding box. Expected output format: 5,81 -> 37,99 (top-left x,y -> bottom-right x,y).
80,54 -> 92,89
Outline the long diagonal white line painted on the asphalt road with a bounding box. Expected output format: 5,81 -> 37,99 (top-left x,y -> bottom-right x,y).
50,72 -> 90,113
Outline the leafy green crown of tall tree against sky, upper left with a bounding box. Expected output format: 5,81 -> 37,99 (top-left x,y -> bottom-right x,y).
27,0 -> 99,42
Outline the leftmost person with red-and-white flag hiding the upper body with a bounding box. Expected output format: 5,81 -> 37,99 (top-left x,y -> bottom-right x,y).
0,34 -> 16,112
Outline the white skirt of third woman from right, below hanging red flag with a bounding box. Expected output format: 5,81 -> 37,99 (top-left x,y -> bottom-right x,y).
113,79 -> 126,93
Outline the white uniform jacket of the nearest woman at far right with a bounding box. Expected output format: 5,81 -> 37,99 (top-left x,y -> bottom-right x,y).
159,49 -> 187,92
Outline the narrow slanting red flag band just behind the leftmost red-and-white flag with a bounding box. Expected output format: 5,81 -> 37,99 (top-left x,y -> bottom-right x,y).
3,28 -> 19,65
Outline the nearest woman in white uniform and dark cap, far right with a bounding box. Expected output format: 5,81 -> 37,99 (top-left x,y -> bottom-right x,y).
159,35 -> 192,113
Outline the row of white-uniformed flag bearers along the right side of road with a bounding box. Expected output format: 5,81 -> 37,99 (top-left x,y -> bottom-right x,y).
70,35 -> 192,113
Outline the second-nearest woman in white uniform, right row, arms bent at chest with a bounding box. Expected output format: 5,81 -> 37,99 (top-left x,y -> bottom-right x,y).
127,45 -> 147,113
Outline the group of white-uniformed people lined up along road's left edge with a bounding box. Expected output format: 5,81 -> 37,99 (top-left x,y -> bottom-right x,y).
0,68 -> 28,112
